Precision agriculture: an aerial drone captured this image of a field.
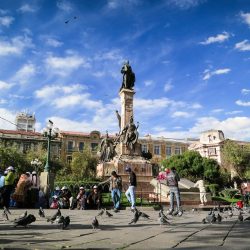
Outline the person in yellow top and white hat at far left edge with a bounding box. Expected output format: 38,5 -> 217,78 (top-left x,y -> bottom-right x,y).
2,166 -> 15,208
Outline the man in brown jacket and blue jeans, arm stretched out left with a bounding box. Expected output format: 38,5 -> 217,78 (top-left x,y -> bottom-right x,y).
99,171 -> 122,213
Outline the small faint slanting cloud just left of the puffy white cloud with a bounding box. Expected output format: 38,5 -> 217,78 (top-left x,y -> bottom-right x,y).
12,63 -> 36,84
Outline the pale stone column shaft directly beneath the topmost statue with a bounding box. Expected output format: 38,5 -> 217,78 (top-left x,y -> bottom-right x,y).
119,88 -> 135,131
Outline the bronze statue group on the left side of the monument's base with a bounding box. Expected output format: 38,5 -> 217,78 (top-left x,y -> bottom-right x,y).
100,132 -> 115,162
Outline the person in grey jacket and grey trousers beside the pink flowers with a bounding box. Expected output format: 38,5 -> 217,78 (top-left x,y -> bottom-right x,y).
166,167 -> 182,216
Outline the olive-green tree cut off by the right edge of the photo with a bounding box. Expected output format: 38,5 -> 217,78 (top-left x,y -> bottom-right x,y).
222,140 -> 250,178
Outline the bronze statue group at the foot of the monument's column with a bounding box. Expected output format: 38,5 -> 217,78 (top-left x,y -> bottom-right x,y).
121,116 -> 139,151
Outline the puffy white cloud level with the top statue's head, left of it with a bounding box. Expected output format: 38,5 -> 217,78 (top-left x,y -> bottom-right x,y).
44,55 -> 90,76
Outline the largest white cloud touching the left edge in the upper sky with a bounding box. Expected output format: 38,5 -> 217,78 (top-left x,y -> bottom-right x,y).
0,36 -> 33,56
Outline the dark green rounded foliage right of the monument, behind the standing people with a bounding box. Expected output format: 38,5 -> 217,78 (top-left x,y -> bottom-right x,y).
162,151 -> 221,183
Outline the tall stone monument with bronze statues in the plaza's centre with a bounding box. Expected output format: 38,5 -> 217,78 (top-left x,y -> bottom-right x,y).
97,62 -> 153,191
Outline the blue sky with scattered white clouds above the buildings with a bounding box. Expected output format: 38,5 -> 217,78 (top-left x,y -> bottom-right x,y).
0,0 -> 250,140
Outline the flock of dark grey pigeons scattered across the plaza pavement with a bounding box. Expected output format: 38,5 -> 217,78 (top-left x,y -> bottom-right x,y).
2,206 -> 250,229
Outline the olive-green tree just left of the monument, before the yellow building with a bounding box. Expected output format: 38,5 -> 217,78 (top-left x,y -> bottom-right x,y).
71,148 -> 98,180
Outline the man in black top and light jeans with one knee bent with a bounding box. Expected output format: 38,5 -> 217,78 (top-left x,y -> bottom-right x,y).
125,166 -> 137,211
